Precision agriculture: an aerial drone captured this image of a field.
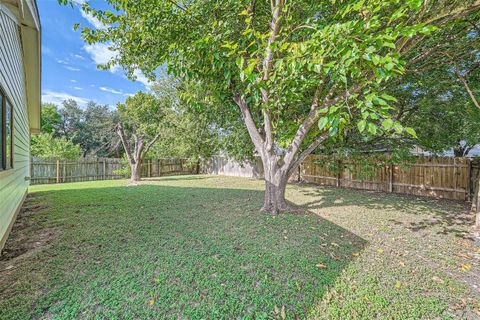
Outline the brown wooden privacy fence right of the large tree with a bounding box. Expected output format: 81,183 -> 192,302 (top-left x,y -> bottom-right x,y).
300,155 -> 472,200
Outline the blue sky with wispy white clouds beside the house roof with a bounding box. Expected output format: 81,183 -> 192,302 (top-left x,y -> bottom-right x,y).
37,0 -> 150,108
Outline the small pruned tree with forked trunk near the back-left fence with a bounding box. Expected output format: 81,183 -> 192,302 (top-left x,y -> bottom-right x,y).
117,92 -> 169,182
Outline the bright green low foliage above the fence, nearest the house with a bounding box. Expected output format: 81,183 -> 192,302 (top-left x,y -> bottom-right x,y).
31,133 -> 81,160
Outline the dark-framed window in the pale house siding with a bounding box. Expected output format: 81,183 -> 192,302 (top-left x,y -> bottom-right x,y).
0,90 -> 13,170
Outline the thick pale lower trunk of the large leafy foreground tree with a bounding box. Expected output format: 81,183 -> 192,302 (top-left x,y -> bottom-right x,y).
262,156 -> 290,215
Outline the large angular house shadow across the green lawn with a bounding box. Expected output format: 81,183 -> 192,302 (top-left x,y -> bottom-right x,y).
0,179 -> 367,319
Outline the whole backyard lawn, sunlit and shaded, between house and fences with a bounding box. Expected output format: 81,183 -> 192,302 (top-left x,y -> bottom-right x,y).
0,176 -> 480,320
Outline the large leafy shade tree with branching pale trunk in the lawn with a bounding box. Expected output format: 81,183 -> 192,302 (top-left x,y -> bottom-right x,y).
61,0 -> 479,213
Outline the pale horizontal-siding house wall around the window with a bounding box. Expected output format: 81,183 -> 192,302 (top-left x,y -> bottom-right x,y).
0,4 -> 30,250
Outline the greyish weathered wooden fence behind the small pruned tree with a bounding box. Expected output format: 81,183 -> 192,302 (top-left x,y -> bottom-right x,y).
30,158 -> 197,184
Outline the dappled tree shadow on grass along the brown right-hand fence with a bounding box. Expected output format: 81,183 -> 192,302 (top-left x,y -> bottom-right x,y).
300,185 -> 475,240
